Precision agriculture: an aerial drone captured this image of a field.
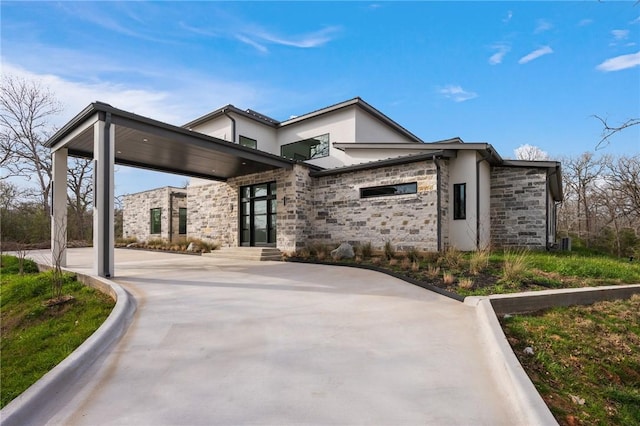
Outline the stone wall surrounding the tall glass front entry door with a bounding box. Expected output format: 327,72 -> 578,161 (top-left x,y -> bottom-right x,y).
187,165 -> 311,252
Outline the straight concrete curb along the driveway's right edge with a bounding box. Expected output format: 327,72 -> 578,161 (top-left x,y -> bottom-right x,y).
464,296 -> 558,425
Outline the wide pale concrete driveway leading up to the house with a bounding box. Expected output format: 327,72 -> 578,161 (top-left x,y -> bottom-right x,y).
26,249 -> 516,425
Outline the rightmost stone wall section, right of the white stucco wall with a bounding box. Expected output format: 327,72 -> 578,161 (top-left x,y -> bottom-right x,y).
491,167 -> 547,249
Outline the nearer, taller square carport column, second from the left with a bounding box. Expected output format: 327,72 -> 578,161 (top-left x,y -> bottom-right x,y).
93,113 -> 115,277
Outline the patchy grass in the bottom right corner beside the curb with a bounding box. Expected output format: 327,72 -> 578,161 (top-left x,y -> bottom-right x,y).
501,295 -> 640,425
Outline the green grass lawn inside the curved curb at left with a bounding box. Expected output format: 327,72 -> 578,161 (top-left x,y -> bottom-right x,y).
0,256 -> 114,408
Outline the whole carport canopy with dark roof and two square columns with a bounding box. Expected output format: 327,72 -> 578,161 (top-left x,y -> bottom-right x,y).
45,102 -> 294,277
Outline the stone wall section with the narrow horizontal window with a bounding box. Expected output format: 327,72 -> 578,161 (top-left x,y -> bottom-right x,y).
310,161 -> 446,251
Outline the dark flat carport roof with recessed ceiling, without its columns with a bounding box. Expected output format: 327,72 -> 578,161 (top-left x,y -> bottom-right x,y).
45,102 -> 295,181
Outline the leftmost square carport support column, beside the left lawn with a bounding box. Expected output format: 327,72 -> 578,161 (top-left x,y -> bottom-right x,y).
50,148 -> 68,266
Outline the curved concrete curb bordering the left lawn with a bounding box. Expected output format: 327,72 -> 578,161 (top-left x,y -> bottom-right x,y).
0,265 -> 136,426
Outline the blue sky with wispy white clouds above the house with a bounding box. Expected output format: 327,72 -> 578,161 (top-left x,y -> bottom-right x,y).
0,1 -> 640,193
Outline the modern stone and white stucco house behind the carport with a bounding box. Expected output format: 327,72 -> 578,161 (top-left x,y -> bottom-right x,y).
118,98 -> 563,252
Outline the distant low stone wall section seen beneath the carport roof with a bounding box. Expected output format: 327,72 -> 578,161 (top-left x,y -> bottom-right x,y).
122,186 -> 189,241
